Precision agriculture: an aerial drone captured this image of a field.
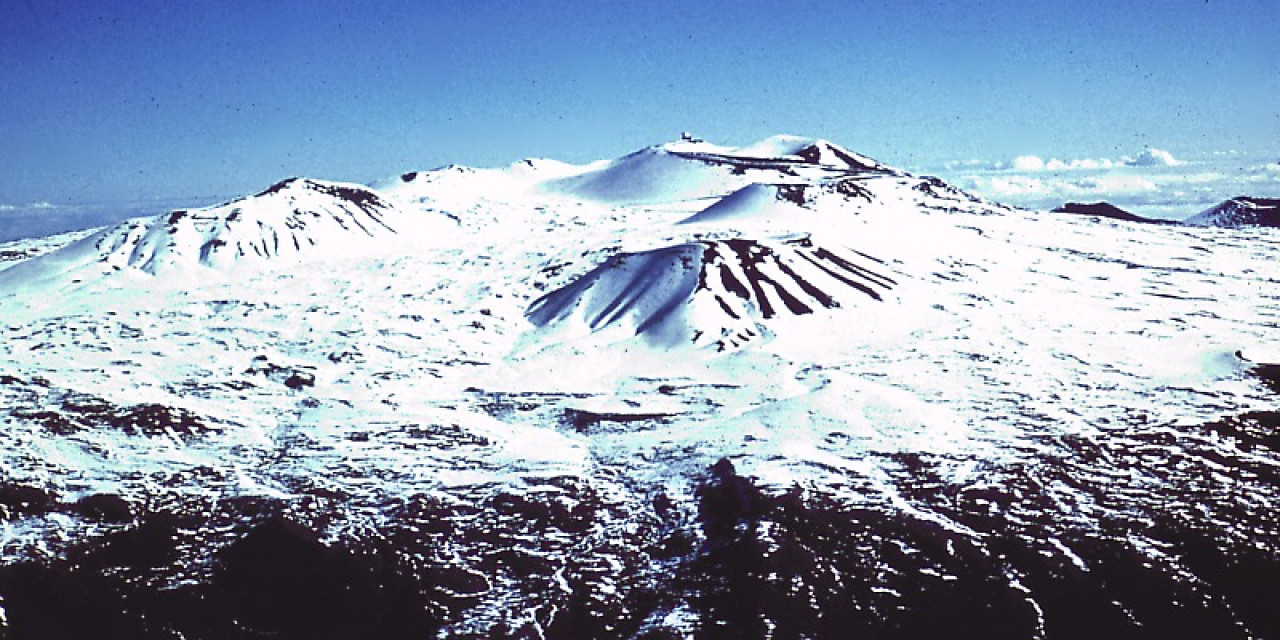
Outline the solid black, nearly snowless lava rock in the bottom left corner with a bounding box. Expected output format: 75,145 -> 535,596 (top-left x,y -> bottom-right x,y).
0,513 -> 436,640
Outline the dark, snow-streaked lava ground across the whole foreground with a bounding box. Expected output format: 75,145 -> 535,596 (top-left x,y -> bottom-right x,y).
0,366 -> 1280,640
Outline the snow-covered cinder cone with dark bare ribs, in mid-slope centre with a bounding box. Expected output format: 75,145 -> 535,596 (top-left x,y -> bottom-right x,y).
529,237 -> 896,351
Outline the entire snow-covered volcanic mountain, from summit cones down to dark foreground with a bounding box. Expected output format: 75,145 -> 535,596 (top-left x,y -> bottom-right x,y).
0,136 -> 1280,639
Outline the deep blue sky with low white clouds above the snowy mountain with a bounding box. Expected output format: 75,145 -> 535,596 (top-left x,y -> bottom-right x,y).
0,0 -> 1280,204
